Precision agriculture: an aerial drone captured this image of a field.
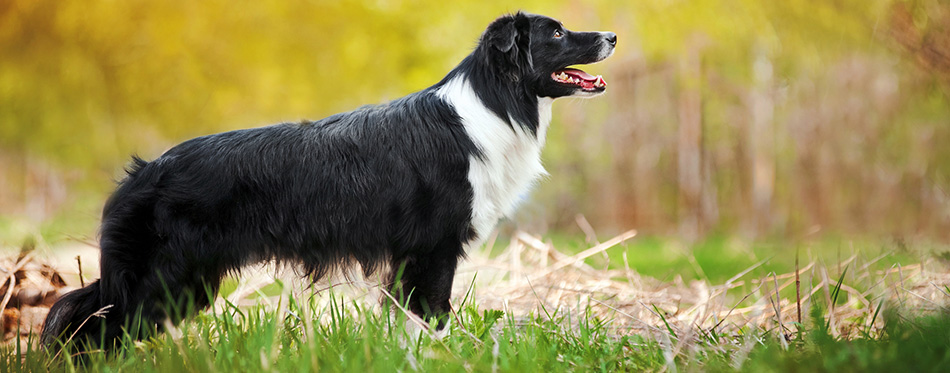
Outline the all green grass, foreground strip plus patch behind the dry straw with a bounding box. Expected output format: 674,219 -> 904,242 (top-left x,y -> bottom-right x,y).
0,236 -> 950,372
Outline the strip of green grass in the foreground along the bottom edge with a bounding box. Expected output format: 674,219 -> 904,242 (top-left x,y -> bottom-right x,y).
0,290 -> 950,372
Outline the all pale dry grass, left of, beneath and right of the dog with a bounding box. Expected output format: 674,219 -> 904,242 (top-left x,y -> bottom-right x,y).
0,231 -> 950,348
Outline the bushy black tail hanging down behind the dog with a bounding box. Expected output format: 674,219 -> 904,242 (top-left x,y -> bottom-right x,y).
40,158 -> 159,348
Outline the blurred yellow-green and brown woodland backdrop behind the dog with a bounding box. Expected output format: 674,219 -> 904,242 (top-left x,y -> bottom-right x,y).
0,0 -> 950,243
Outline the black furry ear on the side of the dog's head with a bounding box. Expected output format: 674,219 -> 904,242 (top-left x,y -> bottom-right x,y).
481,12 -> 534,81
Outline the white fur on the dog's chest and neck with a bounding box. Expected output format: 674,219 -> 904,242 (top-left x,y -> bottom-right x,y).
438,77 -> 554,246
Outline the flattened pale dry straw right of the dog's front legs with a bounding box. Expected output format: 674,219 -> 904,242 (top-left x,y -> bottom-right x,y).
456,232 -> 950,342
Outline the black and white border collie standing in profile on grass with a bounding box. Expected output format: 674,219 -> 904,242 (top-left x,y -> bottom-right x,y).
41,12 -> 617,347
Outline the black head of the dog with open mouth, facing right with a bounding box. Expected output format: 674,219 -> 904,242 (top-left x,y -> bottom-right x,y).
479,12 -> 617,98
